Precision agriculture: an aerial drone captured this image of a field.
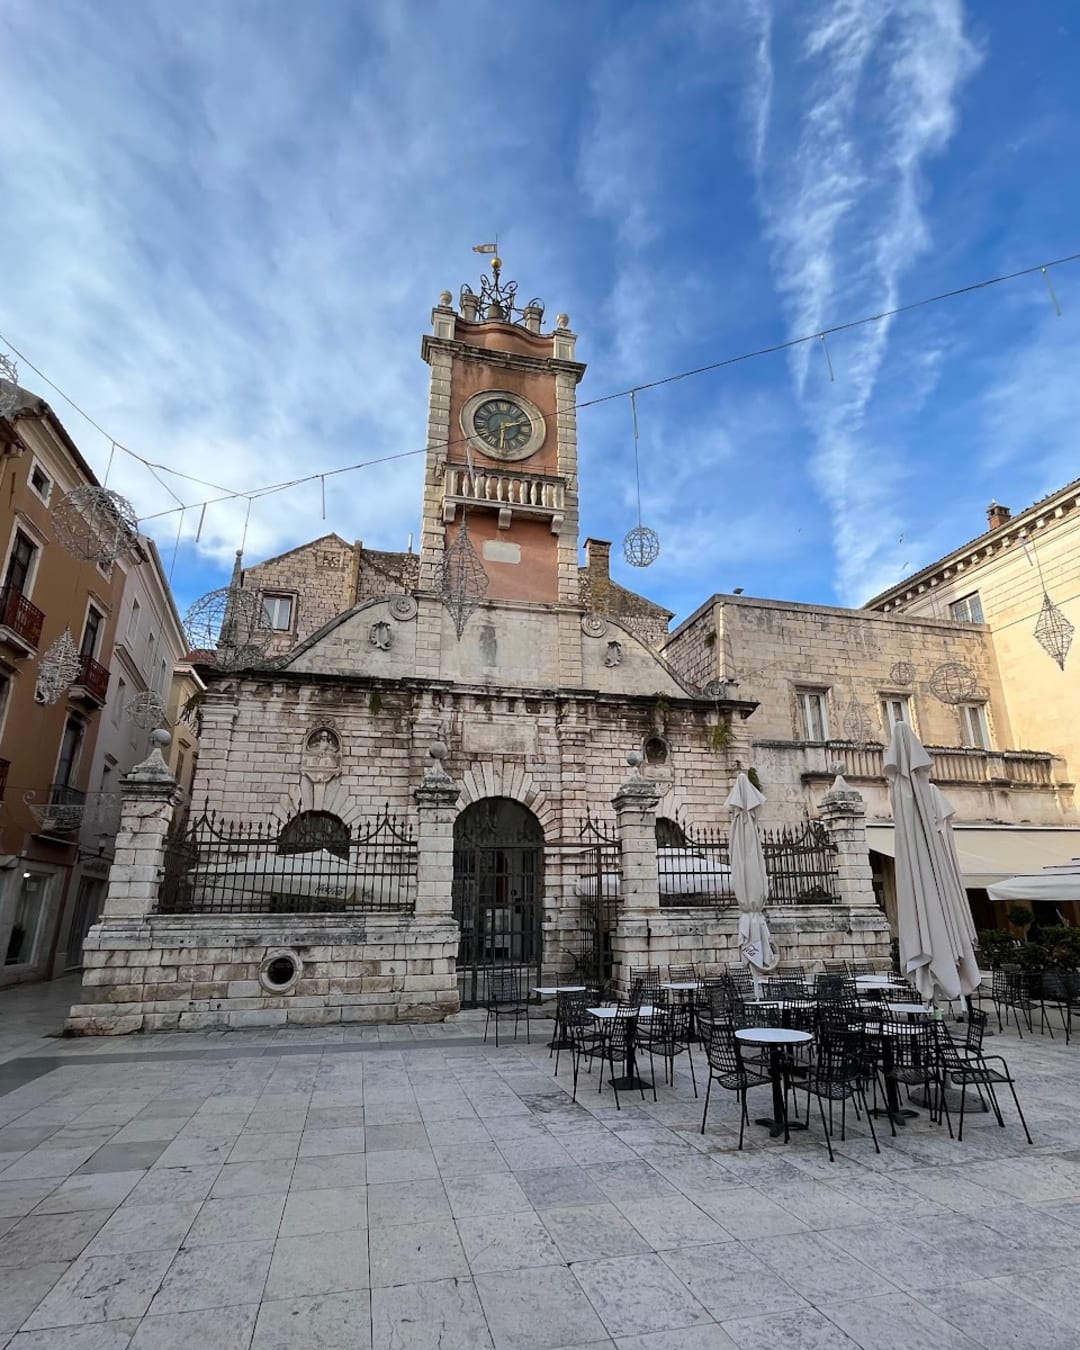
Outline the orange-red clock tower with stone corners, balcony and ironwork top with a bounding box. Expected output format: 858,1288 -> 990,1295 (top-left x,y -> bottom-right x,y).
420,257 -> 585,608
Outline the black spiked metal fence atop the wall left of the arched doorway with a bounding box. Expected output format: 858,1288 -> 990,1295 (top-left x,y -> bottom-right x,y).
158,809 -> 417,914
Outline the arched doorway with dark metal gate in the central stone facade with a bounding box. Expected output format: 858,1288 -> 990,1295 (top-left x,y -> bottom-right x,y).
454,797 -> 544,1007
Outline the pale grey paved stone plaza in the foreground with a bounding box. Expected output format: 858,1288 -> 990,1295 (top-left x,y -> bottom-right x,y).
0,981 -> 1080,1350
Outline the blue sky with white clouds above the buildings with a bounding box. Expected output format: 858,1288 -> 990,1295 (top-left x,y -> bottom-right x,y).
0,0 -> 1080,617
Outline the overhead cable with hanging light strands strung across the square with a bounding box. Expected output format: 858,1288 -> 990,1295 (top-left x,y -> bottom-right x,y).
0,252 -> 1080,537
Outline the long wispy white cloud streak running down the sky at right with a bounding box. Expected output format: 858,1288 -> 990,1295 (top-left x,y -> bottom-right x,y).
749,0 -> 977,602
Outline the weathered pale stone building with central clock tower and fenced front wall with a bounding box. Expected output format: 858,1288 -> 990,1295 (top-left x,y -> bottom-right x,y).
69,260 -> 887,1031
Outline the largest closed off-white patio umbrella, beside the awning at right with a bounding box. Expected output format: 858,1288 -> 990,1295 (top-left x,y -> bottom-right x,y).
884,722 -> 979,1003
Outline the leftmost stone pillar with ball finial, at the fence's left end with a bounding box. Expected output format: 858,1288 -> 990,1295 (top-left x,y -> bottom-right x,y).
101,732 -> 182,925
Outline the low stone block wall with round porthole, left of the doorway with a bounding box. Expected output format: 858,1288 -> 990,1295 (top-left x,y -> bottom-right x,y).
65,914 -> 459,1035
